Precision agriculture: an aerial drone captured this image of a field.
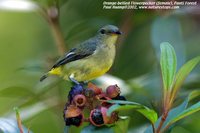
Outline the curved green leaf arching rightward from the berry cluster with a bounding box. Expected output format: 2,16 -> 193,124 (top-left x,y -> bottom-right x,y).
107,100 -> 158,123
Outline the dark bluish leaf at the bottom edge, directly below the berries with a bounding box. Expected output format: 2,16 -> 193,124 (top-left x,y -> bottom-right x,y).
81,125 -> 114,133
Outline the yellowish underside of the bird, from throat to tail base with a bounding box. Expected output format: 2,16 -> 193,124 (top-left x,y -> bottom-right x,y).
49,36 -> 117,81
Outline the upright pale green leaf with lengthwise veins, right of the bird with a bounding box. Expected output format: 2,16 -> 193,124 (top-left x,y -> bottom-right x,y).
160,42 -> 177,90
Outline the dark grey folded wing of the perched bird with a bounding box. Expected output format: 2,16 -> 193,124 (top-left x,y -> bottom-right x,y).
52,40 -> 96,68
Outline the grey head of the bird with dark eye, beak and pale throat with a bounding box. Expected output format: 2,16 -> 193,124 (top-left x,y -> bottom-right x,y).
98,25 -> 122,44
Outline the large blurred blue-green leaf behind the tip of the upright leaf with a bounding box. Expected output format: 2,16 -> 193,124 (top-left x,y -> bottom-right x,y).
151,15 -> 186,68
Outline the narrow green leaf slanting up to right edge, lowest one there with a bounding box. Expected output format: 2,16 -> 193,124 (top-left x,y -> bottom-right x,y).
166,102 -> 200,126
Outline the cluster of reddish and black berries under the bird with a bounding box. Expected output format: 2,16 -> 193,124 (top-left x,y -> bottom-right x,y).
64,83 -> 126,126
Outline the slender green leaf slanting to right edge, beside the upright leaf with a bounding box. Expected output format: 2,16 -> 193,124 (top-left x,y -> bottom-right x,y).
172,56 -> 200,97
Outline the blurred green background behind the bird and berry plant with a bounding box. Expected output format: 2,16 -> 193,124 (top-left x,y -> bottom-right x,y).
0,0 -> 200,133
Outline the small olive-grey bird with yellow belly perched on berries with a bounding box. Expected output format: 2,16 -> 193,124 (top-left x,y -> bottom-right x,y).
40,25 -> 122,84
